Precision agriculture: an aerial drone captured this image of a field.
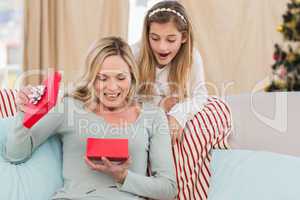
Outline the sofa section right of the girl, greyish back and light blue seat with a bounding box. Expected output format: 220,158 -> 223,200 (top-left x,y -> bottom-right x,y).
208,92 -> 300,200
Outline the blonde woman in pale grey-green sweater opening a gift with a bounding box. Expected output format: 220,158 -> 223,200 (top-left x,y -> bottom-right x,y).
5,37 -> 177,200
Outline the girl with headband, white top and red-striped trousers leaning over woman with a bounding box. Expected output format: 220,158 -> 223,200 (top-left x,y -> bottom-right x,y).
135,1 -> 231,200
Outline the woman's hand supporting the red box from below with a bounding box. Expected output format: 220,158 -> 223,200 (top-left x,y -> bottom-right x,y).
85,157 -> 131,184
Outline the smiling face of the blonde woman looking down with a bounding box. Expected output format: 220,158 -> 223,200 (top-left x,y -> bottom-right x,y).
94,55 -> 131,110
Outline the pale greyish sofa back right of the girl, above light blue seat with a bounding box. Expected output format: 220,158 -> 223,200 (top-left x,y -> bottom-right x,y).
226,92 -> 300,156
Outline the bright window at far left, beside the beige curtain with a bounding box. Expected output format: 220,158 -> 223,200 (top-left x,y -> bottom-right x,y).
0,0 -> 23,88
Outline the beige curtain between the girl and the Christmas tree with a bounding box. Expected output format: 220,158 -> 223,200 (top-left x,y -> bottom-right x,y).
181,0 -> 289,95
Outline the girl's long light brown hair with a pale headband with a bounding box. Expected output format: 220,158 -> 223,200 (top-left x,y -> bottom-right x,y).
138,1 -> 194,100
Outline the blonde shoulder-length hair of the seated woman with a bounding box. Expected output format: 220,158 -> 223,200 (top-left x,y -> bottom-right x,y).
68,37 -> 139,104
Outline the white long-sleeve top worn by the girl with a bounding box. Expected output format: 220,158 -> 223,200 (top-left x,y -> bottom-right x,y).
131,43 -> 208,127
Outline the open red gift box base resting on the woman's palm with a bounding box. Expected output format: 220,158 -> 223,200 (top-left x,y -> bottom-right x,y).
86,138 -> 129,161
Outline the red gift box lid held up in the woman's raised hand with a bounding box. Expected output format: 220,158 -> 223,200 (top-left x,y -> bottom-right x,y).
23,72 -> 61,128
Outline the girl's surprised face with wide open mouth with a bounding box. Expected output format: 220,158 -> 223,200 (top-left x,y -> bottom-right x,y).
149,22 -> 186,65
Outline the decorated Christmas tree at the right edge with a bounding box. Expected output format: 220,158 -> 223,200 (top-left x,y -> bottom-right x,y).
266,0 -> 300,92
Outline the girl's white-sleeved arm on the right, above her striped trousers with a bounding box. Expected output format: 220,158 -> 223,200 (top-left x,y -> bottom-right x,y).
168,50 -> 208,128
